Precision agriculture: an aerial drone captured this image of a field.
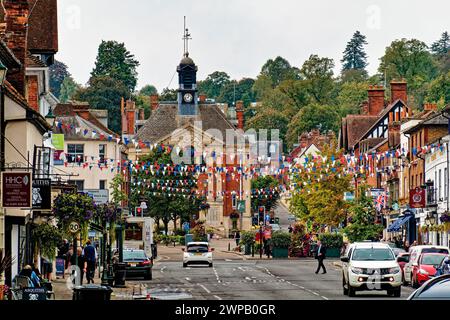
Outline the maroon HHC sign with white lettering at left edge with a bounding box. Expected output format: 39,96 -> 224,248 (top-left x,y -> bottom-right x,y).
2,172 -> 32,208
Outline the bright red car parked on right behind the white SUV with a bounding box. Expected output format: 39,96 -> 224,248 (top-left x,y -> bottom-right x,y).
411,253 -> 446,288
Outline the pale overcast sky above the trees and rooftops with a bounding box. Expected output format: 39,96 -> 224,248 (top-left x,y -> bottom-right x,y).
56,0 -> 450,92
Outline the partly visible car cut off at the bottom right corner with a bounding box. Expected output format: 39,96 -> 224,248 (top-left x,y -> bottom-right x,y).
408,274 -> 450,300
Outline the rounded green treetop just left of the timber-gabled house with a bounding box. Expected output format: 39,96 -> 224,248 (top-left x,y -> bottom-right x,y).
286,103 -> 341,147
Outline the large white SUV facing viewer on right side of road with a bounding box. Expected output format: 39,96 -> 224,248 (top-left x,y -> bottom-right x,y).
341,242 -> 402,297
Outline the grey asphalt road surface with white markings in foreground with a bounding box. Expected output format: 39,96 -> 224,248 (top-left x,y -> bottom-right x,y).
124,257 -> 413,300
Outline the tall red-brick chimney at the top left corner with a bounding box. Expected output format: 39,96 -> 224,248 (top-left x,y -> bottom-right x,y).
3,0 -> 29,96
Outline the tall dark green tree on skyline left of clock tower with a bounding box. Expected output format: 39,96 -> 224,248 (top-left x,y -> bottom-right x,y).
89,41 -> 139,92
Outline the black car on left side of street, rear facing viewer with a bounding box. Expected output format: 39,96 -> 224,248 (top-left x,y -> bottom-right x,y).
123,249 -> 153,280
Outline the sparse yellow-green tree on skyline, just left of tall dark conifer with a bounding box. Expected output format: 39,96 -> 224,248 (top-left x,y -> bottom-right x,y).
300,54 -> 334,103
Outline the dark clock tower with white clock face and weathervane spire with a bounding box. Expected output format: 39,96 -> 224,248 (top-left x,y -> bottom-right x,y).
177,18 -> 198,116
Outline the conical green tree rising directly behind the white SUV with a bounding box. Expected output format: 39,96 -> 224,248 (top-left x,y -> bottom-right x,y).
344,187 -> 383,242
